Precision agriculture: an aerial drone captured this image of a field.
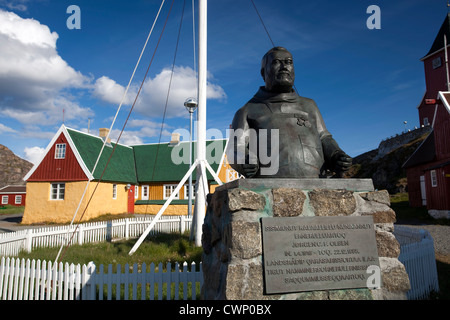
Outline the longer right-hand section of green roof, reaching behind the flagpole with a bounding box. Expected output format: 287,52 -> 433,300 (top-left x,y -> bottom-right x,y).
133,139 -> 226,182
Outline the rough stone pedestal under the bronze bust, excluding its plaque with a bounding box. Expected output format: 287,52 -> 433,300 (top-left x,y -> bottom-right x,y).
202,179 -> 410,300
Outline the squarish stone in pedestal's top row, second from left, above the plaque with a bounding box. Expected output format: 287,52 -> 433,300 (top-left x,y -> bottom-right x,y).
272,188 -> 306,217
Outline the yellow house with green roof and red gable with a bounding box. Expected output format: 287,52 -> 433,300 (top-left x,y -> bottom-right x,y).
22,125 -> 238,224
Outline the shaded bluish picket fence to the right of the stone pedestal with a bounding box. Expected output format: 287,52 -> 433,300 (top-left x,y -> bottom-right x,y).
394,226 -> 439,300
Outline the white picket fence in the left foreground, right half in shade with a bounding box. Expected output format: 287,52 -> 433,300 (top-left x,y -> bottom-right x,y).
0,257 -> 203,300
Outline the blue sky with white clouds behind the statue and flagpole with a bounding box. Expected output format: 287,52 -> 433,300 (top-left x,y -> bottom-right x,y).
0,0 -> 447,165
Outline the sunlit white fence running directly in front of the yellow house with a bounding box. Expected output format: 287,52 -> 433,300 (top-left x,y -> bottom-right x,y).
0,216 -> 192,256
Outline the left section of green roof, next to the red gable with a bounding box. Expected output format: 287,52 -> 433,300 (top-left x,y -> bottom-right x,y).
67,128 -> 137,184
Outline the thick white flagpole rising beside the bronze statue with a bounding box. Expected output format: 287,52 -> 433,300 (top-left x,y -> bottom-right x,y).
194,0 -> 207,246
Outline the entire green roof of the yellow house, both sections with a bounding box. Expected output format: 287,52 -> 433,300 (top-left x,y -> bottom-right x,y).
66,128 -> 226,184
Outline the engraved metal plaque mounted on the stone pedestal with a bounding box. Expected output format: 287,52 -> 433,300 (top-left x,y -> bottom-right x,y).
262,216 -> 379,294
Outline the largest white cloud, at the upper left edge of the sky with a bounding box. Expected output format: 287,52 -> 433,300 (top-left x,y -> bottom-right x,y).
0,9 -> 91,123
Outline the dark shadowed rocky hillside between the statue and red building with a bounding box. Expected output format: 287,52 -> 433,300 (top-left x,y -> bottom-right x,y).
346,128 -> 430,194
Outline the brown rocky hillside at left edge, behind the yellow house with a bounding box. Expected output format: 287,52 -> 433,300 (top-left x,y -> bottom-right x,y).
0,144 -> 33,188
